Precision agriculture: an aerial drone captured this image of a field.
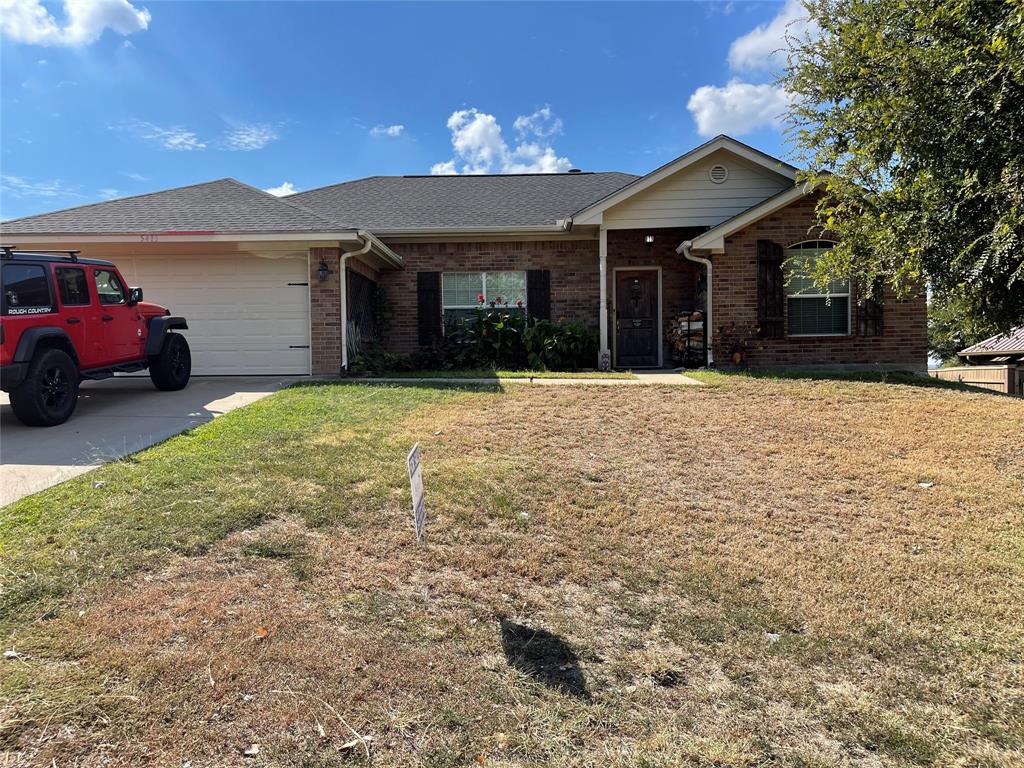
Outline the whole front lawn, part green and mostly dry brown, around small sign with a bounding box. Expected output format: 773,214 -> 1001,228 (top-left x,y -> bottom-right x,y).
0,376 -> 1024,768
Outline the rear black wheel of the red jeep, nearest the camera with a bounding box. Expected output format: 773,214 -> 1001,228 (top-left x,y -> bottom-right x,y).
10,349 -> 79,427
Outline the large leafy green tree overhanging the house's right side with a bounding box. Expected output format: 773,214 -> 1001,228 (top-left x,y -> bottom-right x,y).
782,0 -> 1024,342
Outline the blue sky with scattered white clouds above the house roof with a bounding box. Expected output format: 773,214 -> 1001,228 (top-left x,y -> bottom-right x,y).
0,0 -> 798,218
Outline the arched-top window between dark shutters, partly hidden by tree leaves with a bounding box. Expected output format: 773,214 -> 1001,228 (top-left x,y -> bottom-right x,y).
785,240 -> 850,336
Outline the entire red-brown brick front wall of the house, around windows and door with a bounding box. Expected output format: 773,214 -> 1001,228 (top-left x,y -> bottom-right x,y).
309,199 -> 928,375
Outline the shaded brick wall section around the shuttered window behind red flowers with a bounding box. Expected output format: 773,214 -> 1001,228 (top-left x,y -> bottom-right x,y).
381,240 -> 599,354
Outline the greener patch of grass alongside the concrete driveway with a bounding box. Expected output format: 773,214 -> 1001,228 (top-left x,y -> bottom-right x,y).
0,384 -> 487,632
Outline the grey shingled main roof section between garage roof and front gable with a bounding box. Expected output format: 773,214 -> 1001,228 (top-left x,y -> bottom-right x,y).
286,172 -> 638,234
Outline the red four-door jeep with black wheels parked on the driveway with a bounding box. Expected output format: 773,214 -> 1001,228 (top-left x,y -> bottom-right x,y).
0,246 -> 191,427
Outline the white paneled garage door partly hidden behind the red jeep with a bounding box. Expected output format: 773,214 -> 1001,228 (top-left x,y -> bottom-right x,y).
117,254 -> 309,375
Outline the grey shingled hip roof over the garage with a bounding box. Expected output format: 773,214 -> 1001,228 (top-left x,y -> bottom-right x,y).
2,178 -> 348,238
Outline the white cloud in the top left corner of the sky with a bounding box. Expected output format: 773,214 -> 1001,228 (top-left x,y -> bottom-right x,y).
0,0 -> 152,46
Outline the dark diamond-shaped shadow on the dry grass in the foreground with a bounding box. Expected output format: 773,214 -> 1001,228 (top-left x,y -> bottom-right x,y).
500,618 -> 590,698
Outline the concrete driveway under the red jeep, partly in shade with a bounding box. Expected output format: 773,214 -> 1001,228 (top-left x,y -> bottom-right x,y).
0,376 -> 297,507
